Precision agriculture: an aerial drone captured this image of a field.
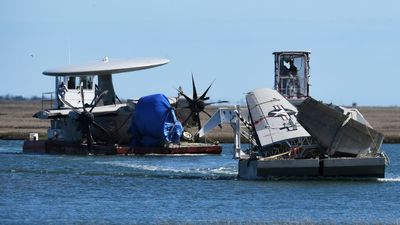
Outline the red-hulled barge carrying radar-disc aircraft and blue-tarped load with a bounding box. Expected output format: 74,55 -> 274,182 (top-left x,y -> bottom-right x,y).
23,57 -> 222,155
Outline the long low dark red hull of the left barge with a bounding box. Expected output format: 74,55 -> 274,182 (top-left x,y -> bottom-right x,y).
23,140 -> 222,155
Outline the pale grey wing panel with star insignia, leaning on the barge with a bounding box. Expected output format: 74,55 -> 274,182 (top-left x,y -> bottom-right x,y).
246,88 -> 310,146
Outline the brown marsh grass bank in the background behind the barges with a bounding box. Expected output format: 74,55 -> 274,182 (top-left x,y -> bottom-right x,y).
0,99 -> 400,143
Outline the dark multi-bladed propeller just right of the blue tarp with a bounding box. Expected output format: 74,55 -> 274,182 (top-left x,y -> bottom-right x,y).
178,73 -> 228,130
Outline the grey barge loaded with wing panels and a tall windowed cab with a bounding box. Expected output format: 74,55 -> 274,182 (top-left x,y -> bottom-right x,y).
198,51 -> 389,180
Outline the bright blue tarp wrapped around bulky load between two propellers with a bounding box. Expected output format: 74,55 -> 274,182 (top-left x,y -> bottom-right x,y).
130,94 -> 183,147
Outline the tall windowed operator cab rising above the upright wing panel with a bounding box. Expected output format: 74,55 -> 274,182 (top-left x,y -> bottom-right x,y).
273,51 -> 310,105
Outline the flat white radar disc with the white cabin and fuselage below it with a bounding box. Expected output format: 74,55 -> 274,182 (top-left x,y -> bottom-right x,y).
34,57 -> 169,143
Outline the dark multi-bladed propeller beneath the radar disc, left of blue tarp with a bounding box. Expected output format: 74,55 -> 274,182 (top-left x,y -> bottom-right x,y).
58,82 -> 110,151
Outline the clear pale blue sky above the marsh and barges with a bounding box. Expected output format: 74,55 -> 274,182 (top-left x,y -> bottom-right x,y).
0,0 -> 400,106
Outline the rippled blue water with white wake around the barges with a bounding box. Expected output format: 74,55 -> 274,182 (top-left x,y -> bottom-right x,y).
0,141 -> 400,224
